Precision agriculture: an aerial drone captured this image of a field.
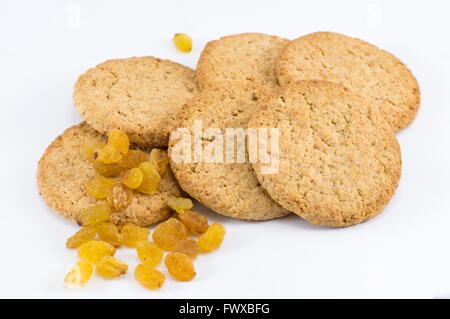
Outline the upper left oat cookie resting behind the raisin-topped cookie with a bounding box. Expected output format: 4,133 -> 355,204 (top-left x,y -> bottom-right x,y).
73,57 -> 198,146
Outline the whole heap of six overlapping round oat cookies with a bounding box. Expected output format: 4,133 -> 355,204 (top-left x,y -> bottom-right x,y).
38,32 -> 420,227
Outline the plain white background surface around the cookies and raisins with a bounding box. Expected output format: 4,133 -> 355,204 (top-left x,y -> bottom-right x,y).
0,0 -> 450,298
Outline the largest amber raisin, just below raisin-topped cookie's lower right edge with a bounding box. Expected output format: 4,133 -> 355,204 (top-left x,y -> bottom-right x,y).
152,218 -> 189,251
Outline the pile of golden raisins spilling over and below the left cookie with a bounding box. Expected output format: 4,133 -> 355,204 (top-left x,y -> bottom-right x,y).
64,130 -> 225,290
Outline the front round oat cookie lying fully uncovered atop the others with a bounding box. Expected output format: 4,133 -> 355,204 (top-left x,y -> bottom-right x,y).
248,80 -> 402,227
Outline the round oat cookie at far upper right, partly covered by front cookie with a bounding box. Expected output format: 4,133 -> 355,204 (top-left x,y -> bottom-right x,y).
276,32 -> 420,132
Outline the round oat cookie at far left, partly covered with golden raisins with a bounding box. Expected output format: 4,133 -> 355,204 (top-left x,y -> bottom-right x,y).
37,122 -> 181,226
